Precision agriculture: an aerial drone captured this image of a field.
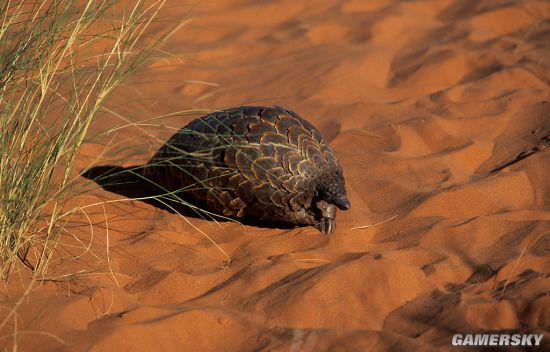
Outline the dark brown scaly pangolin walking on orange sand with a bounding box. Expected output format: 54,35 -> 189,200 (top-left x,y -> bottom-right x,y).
143,106 -> 350,234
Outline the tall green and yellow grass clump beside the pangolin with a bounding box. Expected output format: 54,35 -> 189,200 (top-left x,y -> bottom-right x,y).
0,0 -> 181,278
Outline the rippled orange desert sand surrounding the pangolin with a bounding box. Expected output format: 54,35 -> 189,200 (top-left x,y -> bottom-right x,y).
0,0 -> 550,351
